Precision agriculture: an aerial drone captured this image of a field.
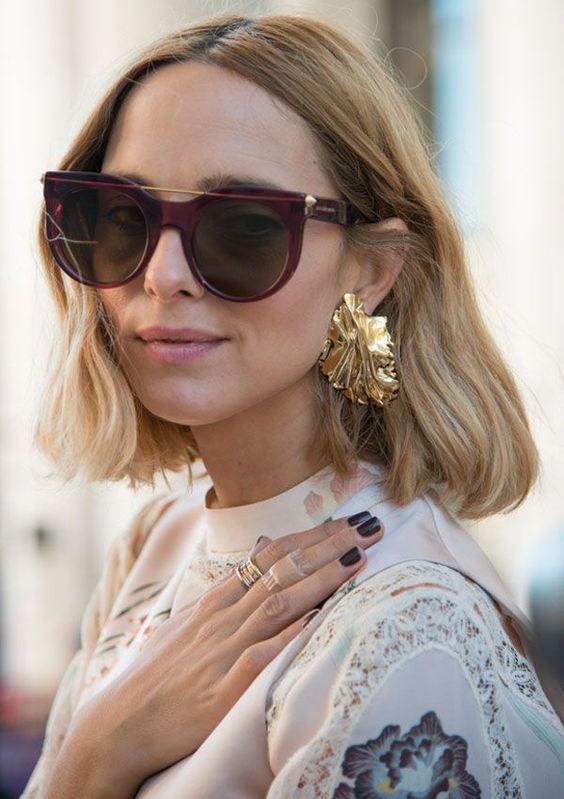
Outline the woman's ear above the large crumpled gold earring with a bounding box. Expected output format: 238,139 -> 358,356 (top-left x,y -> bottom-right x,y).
347,217 -> 409,314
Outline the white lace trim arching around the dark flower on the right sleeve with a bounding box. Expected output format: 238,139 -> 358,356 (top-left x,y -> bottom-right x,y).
266,562 -> 561,799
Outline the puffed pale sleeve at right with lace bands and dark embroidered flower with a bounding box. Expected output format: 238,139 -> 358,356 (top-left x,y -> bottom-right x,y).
267,563 -> 564,799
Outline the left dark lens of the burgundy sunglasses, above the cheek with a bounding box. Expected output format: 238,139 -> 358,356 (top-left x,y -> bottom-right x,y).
57,187 -> 147,284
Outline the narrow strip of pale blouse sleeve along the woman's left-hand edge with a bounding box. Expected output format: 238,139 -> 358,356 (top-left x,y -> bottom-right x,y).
20,494 -> 178,799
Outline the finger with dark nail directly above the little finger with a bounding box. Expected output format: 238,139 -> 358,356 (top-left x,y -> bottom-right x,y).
231,547 -> 366,650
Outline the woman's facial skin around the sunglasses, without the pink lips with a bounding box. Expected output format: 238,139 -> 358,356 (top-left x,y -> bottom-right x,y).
99,62 -> 366,426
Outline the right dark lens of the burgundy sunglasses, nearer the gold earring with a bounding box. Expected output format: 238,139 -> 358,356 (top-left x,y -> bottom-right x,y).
192,200 -> 289,299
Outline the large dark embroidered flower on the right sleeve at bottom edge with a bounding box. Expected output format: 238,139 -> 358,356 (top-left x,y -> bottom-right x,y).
333,711 -> 482,799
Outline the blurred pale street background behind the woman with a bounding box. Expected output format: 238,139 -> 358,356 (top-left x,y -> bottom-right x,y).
0,0 -> 564,797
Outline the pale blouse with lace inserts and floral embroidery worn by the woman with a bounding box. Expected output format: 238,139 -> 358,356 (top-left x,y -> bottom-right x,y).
22,461 -> 564,799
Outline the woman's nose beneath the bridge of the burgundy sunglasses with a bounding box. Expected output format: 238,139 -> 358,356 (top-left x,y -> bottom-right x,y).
144,225 -> 205,301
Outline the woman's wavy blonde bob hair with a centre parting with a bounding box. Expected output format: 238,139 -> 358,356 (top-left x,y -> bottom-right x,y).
35,14 -> 538,518
